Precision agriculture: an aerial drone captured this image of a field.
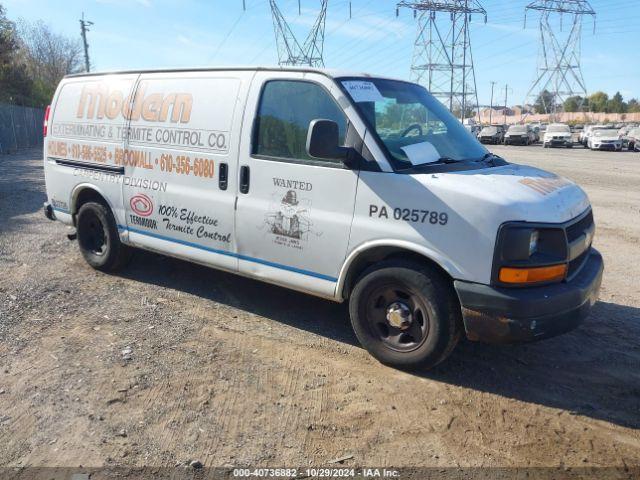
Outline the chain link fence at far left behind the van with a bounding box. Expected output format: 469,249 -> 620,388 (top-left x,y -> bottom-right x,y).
0,103 -> 44,154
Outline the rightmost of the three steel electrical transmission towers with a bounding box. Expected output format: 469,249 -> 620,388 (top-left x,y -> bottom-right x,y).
525,0 -> 596,113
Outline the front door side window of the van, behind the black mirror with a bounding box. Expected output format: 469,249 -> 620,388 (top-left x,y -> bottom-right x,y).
253,80 -> 347,163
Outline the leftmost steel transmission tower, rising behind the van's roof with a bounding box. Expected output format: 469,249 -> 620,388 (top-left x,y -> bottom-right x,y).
269,0 -> 328,67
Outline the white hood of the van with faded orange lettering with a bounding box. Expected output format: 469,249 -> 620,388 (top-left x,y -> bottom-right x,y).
415,164 -> 590,228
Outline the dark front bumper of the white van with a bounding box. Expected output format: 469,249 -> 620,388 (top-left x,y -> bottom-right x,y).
455,249 -> 604,343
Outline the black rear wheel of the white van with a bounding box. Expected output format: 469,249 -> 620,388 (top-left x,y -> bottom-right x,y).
76,202 -> 131,272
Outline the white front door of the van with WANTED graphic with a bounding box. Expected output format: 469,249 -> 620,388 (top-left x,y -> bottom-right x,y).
236,72 -> 358,296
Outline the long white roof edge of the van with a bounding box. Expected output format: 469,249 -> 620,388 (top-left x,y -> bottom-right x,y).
64,66 -> 406,81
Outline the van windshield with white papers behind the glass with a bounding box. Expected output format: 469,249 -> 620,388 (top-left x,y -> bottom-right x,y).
339,78 -> 487,167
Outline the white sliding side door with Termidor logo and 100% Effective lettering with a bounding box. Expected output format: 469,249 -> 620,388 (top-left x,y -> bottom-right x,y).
121,72 -> 251,271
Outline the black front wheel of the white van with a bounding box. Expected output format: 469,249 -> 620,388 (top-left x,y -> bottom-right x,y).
349,260 -> 462,370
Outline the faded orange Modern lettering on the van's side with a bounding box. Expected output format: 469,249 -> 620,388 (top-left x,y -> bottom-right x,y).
76,82 -> 193,123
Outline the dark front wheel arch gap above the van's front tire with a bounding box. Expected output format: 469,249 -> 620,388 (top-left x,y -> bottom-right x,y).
341,246 -> 457,300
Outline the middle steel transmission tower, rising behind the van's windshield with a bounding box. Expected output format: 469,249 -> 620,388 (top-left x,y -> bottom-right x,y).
396,0 -> 487,119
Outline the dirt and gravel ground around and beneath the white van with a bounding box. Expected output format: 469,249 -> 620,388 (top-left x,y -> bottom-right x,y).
0,146 -> 640,467
